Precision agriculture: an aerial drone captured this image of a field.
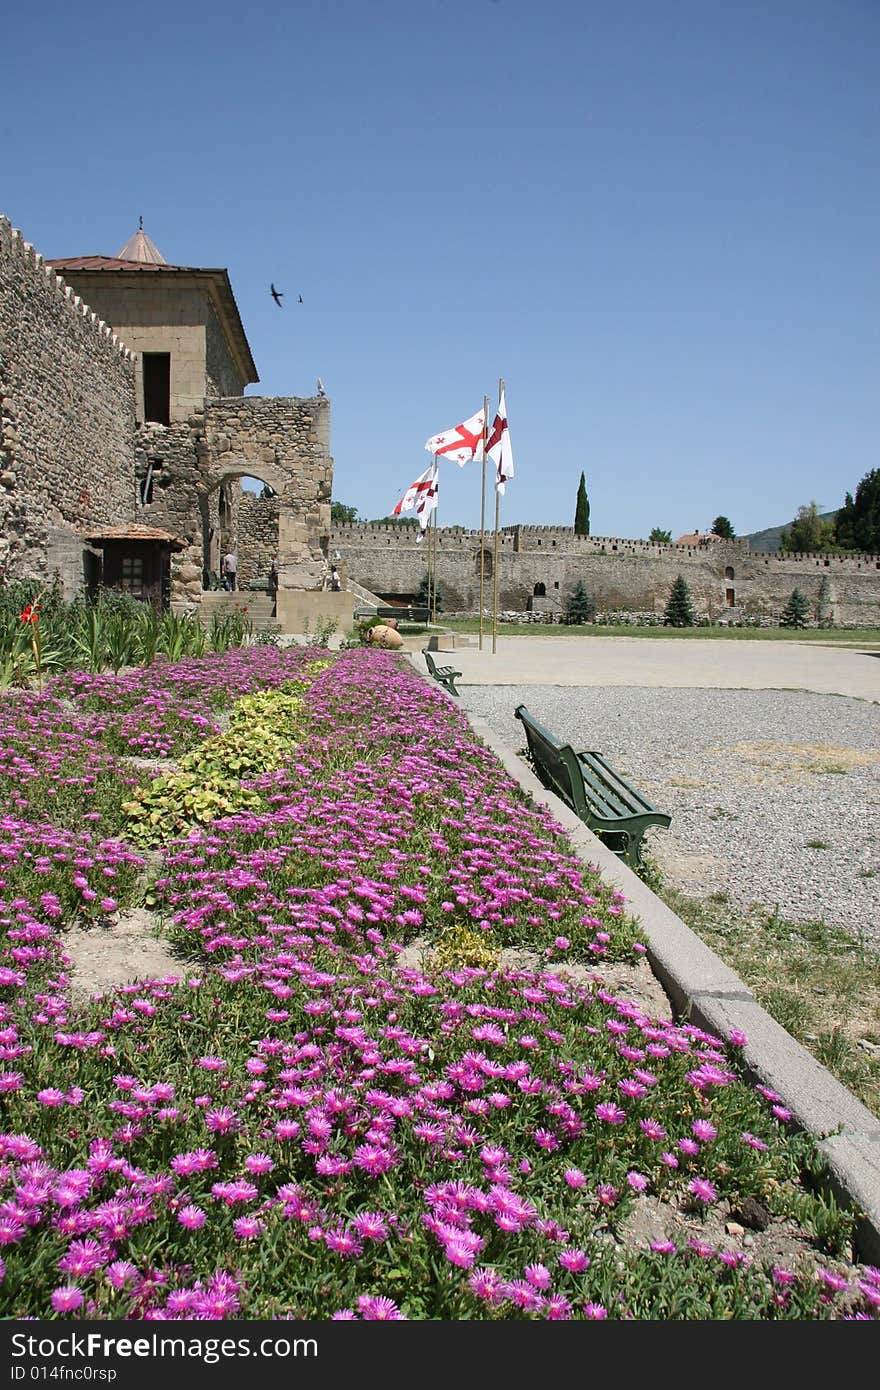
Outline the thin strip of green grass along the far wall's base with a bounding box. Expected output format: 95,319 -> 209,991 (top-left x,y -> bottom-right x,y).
437,613 -> 880,651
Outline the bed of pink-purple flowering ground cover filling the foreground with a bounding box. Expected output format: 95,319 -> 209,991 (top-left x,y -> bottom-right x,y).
0,648 -> 880,1321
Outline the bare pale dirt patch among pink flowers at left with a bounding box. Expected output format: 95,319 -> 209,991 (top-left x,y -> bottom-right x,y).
63,908 -> 186,999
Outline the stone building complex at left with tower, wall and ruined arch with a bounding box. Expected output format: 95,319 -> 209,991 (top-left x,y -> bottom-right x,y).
0,220 -> 344,626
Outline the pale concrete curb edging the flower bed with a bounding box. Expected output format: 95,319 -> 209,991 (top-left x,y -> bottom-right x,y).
463,709 -> 880,1264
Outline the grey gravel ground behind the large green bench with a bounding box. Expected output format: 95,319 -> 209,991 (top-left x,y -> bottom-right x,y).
462,685 -> 880,948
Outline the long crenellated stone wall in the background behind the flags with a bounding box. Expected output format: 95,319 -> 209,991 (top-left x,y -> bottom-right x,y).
329,523 -> 880,627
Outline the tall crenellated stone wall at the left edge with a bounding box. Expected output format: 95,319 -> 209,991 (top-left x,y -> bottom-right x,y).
0,217 -> 135,594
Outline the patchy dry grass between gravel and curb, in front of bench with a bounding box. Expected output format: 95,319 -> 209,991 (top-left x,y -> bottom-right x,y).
649,884 -> 880,1116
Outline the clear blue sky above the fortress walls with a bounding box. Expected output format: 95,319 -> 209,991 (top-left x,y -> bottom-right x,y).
0,0 -> 880,537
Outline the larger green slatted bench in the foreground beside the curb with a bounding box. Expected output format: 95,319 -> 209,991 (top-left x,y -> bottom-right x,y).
514,705 -> 671,869
